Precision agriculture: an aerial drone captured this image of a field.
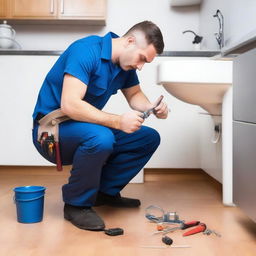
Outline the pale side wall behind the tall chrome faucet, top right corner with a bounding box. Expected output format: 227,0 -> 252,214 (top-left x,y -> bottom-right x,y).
199,0 -> 256,50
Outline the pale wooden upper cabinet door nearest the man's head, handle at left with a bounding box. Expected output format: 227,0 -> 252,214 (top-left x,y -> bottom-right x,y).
59,0 -> 106,19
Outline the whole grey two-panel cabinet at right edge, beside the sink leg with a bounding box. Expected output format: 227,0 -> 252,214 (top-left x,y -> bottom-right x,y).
233,48 -> 256,222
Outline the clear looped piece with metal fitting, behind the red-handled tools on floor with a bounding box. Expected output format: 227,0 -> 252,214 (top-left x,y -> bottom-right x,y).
145,205 -> 184,223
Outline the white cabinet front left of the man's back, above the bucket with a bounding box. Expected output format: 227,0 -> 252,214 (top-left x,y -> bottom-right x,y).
0,55 -> 58,165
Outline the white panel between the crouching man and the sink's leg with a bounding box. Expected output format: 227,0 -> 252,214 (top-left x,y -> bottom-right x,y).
104,57 -> 200,168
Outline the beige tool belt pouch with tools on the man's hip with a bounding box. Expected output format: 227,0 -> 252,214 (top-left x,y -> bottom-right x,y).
37,108 -> 70,171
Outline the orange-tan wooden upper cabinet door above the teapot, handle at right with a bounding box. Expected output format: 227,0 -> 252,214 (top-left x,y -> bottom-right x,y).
11,0 -> 57,19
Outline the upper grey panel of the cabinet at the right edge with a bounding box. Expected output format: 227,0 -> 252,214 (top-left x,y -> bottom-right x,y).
233,49 -> 256,123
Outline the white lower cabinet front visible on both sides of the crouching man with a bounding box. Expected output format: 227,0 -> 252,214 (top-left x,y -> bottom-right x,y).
0,55 -> 200,168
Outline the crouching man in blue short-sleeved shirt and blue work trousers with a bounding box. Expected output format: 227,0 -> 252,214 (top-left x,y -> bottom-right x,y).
33,21 -> 168,231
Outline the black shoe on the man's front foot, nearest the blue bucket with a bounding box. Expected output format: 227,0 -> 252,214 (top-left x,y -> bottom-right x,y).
64,204 -> 105,231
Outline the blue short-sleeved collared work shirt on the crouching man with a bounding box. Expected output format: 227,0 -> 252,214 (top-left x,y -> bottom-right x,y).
33,32 -> 139,119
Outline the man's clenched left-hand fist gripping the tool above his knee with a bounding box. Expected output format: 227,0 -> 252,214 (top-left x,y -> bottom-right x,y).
120,111 -> 144,133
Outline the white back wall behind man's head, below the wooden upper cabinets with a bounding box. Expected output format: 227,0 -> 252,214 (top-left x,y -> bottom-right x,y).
13,0 -> 199,50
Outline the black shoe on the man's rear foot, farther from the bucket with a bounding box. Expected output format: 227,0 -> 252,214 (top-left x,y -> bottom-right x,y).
94,192 -> 140,208
